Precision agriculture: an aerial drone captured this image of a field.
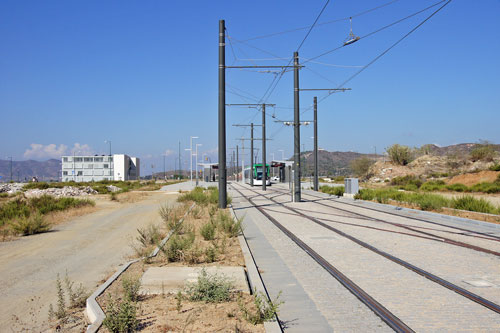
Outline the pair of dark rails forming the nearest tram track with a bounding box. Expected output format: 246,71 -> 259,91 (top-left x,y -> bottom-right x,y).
232,184 -> 500,318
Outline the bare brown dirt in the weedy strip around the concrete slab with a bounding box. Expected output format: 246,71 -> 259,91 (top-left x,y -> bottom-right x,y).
94,201 -> 264,332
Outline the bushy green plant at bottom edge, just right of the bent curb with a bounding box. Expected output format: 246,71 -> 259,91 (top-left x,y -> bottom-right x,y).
103,295 -> 139,333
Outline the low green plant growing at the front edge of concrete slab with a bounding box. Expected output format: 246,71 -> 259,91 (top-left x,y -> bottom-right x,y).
186,268 -> 233,303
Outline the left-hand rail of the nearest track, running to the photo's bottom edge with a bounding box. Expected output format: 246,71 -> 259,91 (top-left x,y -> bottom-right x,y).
231,184 -> 414,332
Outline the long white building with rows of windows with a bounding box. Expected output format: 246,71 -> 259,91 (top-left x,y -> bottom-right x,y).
61,154 -> 141,182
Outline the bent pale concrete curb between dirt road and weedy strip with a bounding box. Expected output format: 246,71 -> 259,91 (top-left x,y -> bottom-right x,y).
85,203 -> 195,333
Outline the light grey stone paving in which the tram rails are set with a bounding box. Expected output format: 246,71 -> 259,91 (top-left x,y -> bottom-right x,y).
230,185 -> 500,332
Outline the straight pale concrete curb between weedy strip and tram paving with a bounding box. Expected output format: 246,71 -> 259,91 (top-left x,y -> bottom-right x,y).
229,205 -> 283,333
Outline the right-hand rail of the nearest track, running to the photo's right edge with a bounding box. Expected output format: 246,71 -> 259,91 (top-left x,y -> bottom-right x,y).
233,185 -> 500,313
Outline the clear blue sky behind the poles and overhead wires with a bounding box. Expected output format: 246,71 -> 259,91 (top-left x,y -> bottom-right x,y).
0,0 -> 500,173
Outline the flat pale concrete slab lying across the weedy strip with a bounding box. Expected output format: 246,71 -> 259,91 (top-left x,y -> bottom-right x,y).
139,266 -> 250,295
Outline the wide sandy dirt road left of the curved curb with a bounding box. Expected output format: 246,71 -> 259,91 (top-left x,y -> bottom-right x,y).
0,192 -> 176,332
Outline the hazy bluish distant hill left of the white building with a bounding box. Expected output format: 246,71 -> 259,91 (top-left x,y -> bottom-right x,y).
0,159 -> 61,182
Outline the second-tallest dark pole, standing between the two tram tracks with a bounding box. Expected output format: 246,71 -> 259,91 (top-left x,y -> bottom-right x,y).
293,52 -> 301,202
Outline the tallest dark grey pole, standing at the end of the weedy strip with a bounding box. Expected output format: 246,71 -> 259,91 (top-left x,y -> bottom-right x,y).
219,20 -> 227,208
